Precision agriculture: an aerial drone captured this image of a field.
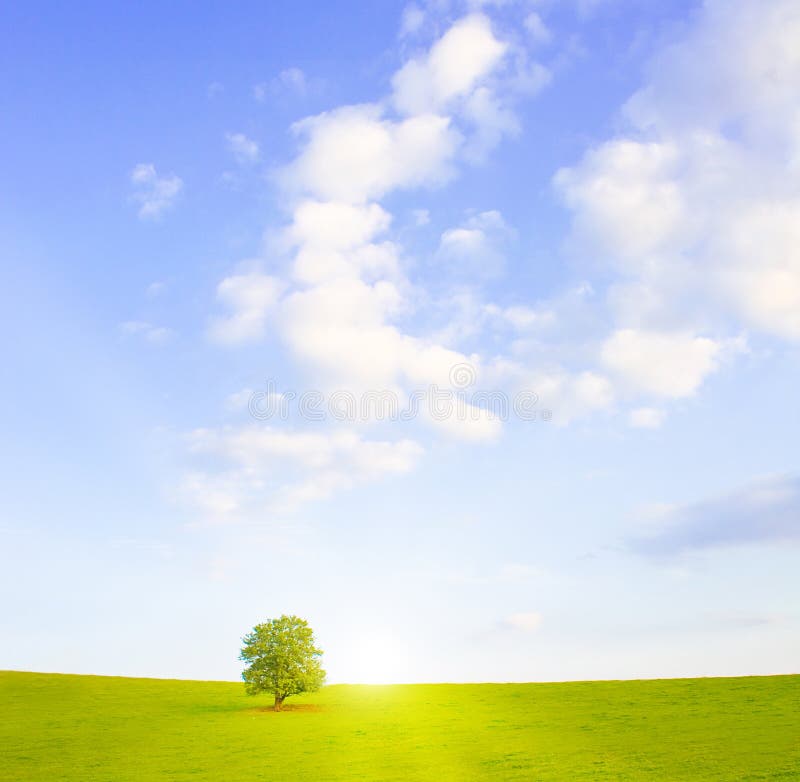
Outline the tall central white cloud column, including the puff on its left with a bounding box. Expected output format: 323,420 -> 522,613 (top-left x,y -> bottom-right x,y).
212,14 -> 544,422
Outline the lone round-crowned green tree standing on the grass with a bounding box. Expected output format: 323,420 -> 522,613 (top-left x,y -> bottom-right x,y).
239,615 -> 325,711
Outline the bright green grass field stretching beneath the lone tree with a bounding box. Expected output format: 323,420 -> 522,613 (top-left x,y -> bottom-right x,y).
0,672 -> 800,782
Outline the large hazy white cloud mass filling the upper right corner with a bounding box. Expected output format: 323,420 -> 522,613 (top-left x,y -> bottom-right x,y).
556,0 -> 800,350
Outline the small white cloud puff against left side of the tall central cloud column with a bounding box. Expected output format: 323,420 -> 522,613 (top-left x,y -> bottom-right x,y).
209,272 -> 283,345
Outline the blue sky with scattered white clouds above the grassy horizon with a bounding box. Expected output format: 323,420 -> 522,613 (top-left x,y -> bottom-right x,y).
0,0 -> 800,682
